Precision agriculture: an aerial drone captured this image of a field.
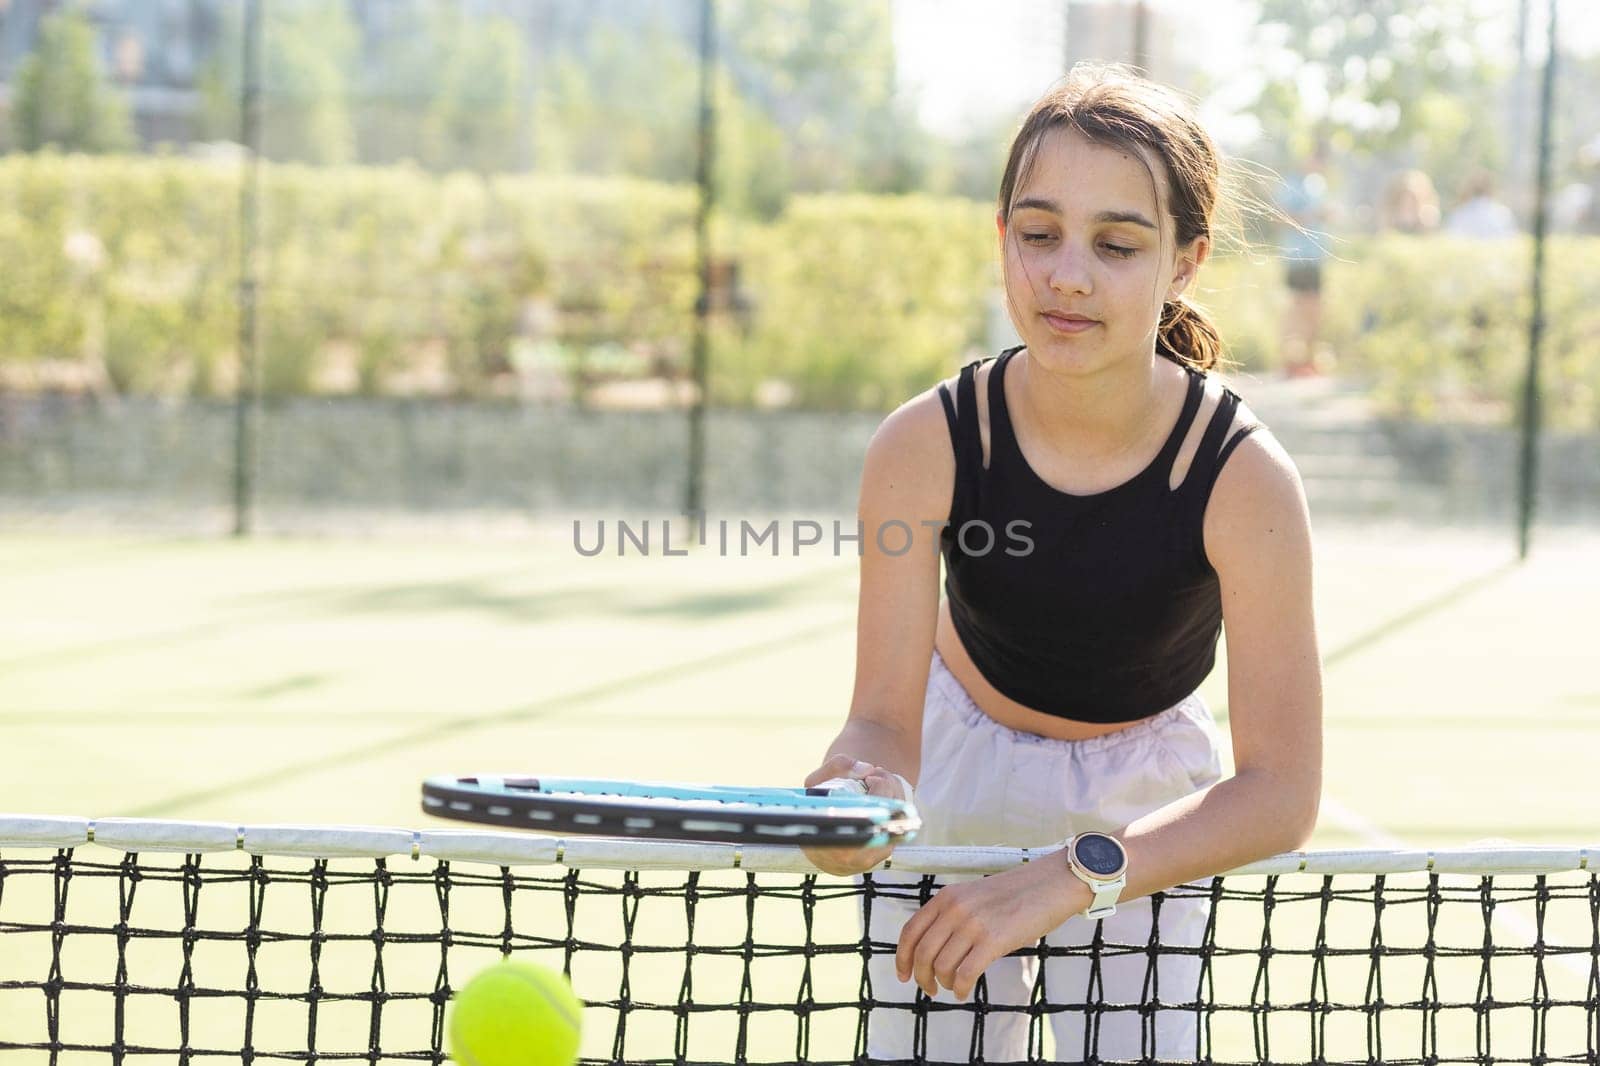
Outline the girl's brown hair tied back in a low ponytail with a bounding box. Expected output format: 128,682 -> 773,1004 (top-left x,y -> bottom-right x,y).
1000,64 -> 1224,370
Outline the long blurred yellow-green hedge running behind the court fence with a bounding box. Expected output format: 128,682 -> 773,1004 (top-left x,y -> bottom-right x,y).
9,152 -> 1600,427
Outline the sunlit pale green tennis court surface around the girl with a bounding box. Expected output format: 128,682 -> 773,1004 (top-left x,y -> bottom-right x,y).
0,525 -> 1600,1063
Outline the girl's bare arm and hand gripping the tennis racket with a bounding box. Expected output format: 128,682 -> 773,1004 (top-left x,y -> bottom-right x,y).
805,391 -> 955,874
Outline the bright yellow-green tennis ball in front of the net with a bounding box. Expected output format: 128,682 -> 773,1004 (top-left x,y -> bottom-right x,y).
450,962 -> 584,1066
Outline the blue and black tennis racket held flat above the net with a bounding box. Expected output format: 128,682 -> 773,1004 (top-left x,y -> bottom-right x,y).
422,775 -> 922,848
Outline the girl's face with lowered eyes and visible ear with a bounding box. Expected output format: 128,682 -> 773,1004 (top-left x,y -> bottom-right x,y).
995,130 -> 1206,373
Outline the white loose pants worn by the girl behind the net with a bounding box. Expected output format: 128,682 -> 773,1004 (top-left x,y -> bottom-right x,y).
866,651 -> 1222,1063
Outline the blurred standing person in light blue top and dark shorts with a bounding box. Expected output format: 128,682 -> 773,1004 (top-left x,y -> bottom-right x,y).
1278,144 -> 1333,378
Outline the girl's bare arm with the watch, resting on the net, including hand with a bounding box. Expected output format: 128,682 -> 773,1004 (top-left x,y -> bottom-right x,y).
896,422 -> 1322,999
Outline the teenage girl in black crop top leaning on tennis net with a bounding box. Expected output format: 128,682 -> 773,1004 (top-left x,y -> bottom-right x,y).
806,67 -> 1322,1061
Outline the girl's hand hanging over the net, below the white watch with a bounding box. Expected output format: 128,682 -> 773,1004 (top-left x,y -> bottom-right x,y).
894,852 -> 1093,1000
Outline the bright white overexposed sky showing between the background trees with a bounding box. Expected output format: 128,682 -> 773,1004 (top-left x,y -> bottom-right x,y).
891,0 -> 1600,146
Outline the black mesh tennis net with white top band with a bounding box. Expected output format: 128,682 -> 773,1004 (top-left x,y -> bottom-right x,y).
0,816 -> 1600,1066
